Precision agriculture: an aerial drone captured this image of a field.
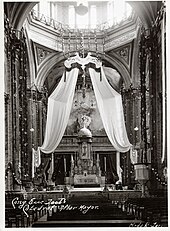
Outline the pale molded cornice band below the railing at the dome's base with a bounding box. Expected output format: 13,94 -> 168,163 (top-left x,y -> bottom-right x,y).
26,10 -> 139,56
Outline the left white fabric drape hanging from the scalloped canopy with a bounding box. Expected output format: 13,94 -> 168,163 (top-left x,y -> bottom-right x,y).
38,68 -> 79,160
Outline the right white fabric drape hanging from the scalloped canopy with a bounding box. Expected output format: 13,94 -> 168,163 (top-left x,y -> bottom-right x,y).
89,67 -> 131,152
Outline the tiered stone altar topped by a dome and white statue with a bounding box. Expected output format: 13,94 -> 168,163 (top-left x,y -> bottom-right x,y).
65,116 -> 105,187
